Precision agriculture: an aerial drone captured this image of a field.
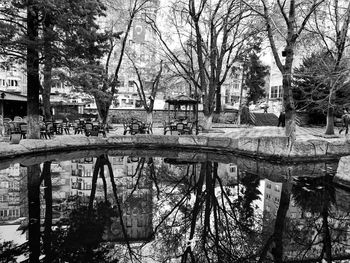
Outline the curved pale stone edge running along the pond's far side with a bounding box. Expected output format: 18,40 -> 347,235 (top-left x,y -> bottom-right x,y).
0,134 -> 350,158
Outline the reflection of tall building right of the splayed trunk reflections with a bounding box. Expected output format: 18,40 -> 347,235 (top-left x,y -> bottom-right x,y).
103,156 -> 153,241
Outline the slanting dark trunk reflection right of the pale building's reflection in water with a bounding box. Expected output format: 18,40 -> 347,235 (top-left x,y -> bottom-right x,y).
272,182 -> 292,262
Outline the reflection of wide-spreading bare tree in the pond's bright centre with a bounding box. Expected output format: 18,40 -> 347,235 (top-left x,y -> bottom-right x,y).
150,162 -> 266,262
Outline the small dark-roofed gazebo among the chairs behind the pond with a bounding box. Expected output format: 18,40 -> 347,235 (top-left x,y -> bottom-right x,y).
165,95 -> 198,134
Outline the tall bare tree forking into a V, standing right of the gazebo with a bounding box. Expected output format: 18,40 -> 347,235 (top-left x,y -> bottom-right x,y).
245,0 -> 325,142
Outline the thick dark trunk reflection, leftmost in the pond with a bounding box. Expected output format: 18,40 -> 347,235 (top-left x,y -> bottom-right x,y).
27,164 -> 40,262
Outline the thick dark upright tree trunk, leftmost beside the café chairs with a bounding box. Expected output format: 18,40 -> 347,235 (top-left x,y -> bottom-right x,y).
27,3 -> 40,139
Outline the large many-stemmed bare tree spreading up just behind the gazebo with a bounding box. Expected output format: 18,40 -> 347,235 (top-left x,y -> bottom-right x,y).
151,0 -> 257,129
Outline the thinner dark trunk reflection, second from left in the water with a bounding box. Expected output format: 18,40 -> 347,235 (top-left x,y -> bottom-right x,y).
42,162 -> 52,262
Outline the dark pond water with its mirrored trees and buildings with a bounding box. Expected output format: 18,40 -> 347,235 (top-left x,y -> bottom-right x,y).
0,153 -> 350,262
